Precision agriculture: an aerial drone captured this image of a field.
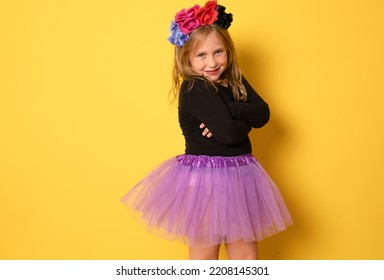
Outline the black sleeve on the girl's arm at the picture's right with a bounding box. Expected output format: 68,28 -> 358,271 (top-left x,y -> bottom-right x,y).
228,78 -> 270,128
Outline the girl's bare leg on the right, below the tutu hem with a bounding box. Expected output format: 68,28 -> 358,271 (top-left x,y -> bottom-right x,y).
225,240 -> 258,260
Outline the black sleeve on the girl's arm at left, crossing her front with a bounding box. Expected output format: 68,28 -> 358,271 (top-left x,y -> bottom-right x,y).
180,79 -> 251,146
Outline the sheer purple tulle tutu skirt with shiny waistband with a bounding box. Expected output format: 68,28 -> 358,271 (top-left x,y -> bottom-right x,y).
121,154 -> 292,247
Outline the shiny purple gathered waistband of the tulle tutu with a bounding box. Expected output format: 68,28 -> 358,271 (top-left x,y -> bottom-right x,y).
176,154 -> 257,168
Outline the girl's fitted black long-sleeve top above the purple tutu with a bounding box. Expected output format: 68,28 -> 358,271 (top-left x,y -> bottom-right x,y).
179,78 -> 269,156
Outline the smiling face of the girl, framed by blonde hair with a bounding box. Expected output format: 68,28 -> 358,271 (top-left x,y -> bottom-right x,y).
189,32 -> 227,83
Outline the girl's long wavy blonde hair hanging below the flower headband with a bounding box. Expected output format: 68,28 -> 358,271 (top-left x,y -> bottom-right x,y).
170,25 -> 247,101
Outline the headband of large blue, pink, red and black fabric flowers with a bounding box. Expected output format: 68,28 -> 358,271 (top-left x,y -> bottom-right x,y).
168,0 -> 232,47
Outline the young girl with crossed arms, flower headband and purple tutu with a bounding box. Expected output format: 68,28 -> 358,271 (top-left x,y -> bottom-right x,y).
122,1 -> 292,259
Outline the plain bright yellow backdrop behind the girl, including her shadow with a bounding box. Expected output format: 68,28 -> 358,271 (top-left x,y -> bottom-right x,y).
0,0 -> 384,259
